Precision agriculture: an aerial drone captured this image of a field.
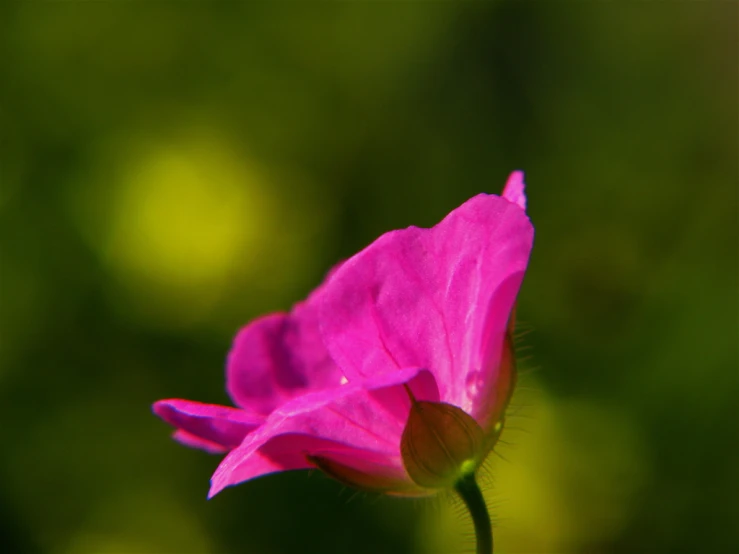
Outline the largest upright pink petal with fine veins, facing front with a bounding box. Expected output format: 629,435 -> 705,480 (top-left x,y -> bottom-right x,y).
321,194 -> 533,416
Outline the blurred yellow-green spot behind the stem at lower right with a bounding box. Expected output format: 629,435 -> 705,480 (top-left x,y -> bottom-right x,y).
422,388 -> 647,554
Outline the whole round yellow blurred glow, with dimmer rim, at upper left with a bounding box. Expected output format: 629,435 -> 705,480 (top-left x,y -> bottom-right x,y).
70,125 -> 294,328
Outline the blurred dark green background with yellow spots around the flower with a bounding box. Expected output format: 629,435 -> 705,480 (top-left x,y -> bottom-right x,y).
0,1 -> 739,554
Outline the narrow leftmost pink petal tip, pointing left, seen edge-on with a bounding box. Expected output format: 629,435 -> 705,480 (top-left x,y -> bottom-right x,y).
153,399 -> 264,452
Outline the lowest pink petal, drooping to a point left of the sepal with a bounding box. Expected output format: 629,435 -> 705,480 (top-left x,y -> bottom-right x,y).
209,368 -> 434,497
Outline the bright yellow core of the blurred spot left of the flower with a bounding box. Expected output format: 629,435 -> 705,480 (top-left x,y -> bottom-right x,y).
106,134 -> 270,293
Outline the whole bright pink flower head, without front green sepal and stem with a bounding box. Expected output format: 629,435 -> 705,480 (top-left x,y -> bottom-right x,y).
154,172 -> 534,496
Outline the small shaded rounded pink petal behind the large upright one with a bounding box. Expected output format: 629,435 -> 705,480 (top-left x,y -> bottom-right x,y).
226,274 -> 343,415
